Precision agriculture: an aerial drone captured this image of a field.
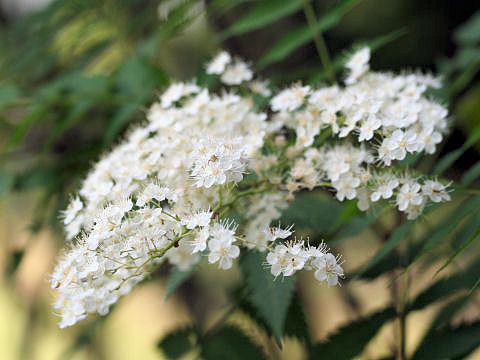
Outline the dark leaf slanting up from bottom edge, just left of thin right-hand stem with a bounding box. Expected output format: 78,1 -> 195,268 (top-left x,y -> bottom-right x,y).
310,307 -> 396,360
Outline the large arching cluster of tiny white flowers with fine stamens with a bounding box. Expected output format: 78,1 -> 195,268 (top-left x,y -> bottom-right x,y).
51,49 -> 449,327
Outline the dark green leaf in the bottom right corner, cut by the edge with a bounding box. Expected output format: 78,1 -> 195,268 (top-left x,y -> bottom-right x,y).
412,321 -> 480,360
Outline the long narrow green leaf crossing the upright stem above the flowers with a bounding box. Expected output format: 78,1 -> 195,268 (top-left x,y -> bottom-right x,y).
258,0 -> 358,69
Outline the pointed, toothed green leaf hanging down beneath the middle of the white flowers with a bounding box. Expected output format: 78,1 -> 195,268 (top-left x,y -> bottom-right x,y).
240,251 -> 295,344
